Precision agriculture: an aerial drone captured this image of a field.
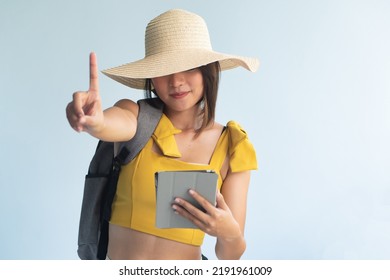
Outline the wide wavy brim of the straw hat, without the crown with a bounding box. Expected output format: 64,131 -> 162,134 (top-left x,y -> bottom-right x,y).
102,49 -> 259,89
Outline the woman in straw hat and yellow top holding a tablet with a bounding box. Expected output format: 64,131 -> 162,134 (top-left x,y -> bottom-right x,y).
67,10 -> 258,259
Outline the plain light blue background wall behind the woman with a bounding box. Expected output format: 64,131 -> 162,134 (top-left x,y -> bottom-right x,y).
0,0 -> 390,259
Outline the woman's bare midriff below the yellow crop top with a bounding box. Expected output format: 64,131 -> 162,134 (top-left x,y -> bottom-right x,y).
107,224 -> 201,260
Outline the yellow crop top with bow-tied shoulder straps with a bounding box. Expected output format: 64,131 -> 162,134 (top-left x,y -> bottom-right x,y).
110,114 -> 257,246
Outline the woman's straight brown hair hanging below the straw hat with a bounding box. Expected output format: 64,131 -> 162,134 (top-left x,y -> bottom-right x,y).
145,61 -> 221,135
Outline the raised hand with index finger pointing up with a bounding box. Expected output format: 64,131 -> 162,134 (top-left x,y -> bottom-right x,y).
66,52 -> 104,135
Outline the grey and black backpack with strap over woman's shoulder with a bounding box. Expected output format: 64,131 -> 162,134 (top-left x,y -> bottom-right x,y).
77,98 -> 163,260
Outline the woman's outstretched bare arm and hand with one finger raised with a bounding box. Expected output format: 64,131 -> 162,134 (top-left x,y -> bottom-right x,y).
66,53 -> 138,142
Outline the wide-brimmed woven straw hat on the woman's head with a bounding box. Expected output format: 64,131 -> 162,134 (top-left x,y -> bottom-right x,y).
102,9 -> 259,89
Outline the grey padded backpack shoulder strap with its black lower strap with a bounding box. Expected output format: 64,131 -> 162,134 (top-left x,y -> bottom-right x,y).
97,98 -> 163,260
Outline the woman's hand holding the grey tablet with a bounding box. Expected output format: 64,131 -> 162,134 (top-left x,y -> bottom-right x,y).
172,190 -> 242,240
